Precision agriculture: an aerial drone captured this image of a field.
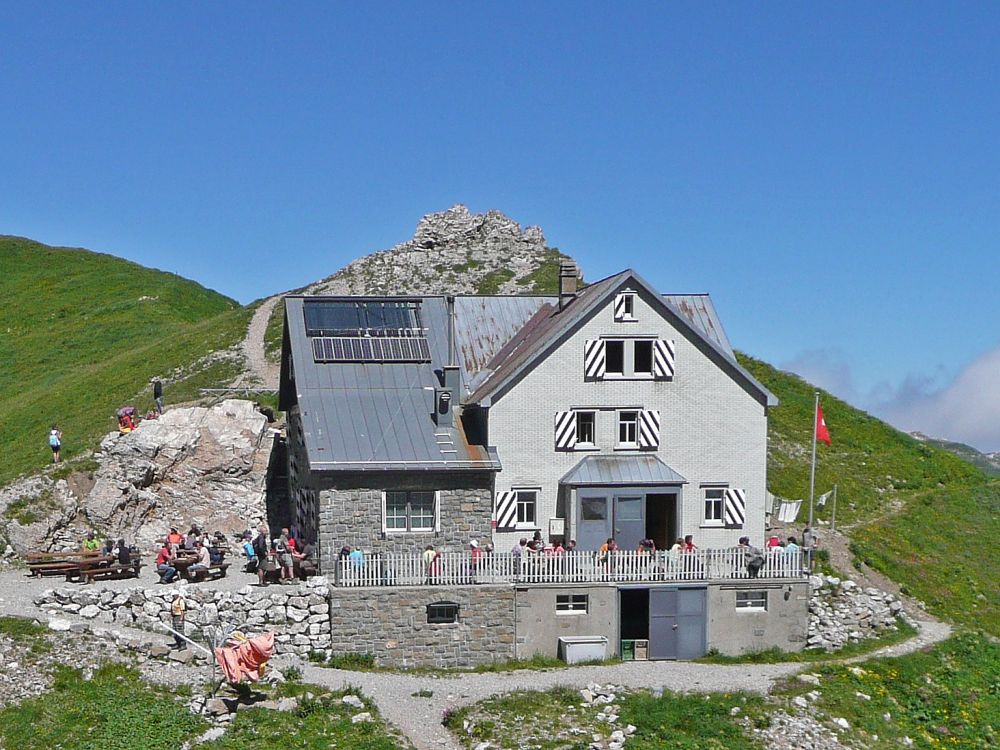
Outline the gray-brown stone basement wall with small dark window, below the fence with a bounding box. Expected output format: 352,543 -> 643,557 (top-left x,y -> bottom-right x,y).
330,586 -> 514,667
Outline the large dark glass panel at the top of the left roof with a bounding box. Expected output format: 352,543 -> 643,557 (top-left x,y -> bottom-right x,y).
302,301 -> 422,337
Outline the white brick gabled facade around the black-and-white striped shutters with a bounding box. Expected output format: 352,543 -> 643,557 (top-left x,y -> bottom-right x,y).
489,282 -> 767,550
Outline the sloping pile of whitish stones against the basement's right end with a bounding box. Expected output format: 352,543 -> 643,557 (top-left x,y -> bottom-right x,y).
806,576 -> 912,651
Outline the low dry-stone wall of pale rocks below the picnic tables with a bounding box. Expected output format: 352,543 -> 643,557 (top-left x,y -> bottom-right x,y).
35,578 -> 330,655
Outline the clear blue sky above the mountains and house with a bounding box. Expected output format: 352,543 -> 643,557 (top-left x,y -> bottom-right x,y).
0,1 -> 1000,450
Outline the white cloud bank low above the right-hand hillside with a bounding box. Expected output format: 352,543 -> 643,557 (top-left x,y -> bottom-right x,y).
781,347 -> 1000,451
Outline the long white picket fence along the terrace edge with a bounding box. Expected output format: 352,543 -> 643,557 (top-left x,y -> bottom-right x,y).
334,548 -> 809,586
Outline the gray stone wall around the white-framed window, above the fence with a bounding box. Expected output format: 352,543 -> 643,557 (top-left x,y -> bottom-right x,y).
319,471 -> 493,572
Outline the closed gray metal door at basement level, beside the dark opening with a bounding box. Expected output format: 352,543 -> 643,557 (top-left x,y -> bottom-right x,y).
649,588 -> 707,659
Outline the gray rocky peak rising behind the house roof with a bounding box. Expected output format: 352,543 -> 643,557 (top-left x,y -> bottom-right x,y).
308,204 -> 563,302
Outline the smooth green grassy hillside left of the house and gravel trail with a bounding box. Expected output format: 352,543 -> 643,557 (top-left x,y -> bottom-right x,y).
0,237 -> 247,483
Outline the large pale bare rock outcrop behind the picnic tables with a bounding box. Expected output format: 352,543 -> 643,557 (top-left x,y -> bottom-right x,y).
0,399 -> 271,553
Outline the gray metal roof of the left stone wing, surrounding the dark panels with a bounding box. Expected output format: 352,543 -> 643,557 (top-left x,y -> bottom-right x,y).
285,297 -> 500,471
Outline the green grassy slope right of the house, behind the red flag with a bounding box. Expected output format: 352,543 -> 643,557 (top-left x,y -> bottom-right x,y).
740,356 -> 1000,635
